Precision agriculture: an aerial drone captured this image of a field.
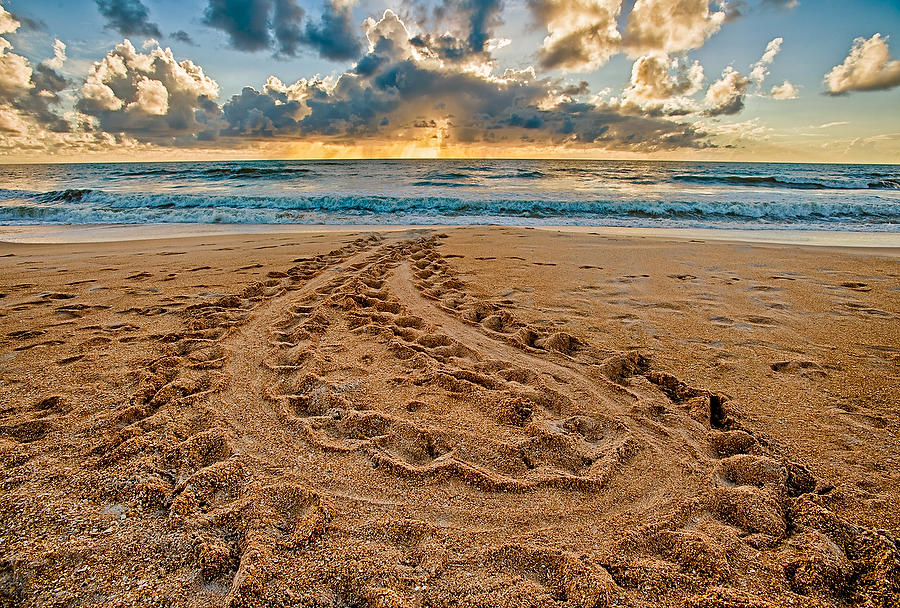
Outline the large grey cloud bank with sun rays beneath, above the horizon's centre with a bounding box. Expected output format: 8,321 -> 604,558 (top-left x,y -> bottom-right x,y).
216,11 -> 705,151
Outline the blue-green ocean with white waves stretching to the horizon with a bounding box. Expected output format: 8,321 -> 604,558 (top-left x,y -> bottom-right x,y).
0,160 -> 900,232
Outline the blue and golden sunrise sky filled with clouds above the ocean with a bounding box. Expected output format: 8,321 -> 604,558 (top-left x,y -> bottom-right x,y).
0,0 -> 900,163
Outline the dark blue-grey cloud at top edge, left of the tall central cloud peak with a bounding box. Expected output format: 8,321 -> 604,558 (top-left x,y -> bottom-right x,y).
204,0 -> 361,60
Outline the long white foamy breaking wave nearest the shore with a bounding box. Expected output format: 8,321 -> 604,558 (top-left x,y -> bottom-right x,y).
0,189 -> 900,230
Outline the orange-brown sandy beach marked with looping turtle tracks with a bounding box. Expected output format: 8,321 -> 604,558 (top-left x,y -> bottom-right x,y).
0,227 -> 900,608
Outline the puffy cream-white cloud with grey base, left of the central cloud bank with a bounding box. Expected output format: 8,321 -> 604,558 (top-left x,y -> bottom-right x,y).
76,39 -> 219,143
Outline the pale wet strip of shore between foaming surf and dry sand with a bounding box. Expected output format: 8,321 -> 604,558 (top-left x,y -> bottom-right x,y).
0,224 -> 900,249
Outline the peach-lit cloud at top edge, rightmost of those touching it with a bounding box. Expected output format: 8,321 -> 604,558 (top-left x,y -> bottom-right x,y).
624,0 -> 726,56
